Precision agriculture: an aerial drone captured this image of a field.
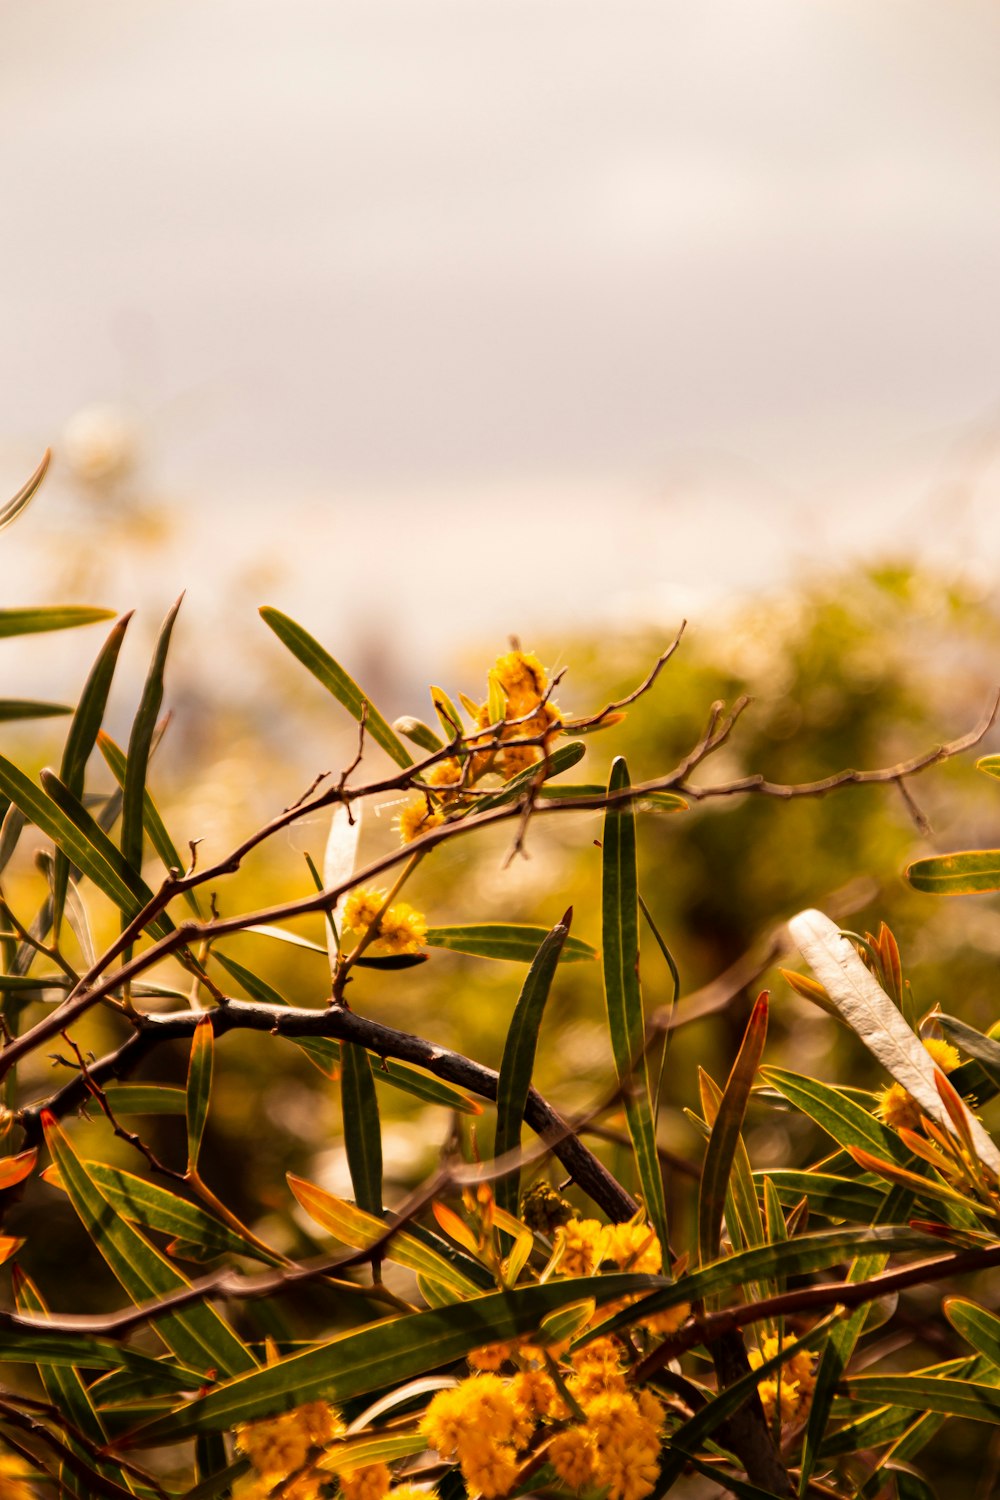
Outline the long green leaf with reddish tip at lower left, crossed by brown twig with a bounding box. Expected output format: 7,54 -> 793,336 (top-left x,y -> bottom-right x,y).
42,1112 -> 255,1374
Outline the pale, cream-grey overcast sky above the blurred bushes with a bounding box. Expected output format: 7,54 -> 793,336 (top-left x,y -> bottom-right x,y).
0,0 -> 1000,678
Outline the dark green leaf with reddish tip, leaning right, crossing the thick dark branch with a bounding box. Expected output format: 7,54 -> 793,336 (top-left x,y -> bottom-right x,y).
493,908 -> 573,1214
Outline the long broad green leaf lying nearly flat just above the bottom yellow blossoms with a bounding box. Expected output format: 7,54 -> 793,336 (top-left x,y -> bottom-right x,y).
132,1272 -> 661,1448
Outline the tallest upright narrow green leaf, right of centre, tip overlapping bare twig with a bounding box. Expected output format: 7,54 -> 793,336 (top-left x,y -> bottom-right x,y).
601,756 -> 669,1248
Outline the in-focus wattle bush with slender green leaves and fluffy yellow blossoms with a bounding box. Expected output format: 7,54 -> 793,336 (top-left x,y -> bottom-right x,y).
0,471 -> 1000,1500
